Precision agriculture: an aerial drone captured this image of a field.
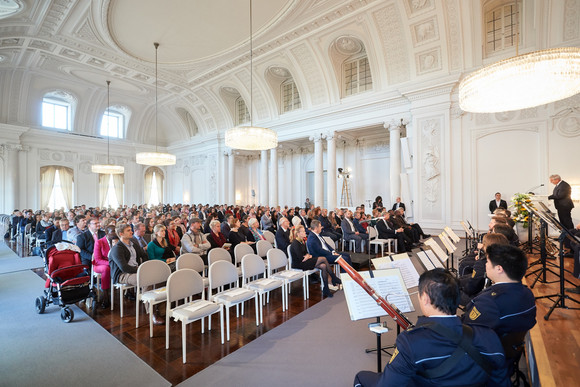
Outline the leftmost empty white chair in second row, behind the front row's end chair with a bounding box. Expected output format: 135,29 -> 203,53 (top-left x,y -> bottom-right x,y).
135,259 -> 171,337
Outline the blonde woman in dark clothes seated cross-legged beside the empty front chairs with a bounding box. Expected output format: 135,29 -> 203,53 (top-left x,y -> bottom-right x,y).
290,224 -> 342,297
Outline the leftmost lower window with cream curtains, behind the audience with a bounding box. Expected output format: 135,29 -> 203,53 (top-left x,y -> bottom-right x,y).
40,165 -> 74,211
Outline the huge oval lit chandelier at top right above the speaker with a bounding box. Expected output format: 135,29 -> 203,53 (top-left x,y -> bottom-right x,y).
459,1 -> 580,113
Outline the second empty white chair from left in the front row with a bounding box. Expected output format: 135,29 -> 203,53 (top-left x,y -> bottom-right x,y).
208,260 -> 260,341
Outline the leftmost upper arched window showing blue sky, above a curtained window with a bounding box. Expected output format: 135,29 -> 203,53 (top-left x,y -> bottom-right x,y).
42,90 -> 76,130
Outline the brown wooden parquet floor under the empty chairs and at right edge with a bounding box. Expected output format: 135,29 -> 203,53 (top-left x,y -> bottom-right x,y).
13,238 -> 580,387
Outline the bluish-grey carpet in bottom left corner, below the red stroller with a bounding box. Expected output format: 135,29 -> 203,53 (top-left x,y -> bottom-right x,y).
0,270 -> 170,386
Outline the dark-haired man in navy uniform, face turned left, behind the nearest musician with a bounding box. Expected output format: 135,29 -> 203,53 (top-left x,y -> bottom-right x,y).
463,244 -> 536,338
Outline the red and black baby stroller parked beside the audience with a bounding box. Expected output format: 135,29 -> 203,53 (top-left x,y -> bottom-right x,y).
36,246 -> 94,323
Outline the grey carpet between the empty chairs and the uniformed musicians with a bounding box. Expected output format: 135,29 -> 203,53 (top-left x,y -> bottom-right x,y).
180,289 -> 419,387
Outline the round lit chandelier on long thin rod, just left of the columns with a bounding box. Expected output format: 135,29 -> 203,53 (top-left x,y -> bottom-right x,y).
226,0 -> 278,150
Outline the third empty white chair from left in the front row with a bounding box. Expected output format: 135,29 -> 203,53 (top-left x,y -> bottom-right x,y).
242,253 -> 286,323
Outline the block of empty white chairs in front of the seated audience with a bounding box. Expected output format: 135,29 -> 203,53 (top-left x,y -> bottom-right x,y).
106,241 -> 318,363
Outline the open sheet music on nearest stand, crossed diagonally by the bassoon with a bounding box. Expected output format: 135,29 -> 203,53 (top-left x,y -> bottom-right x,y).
341,269 -> 415,321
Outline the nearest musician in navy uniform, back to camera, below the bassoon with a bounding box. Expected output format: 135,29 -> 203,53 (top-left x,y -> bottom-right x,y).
354,269 -> 511,387
